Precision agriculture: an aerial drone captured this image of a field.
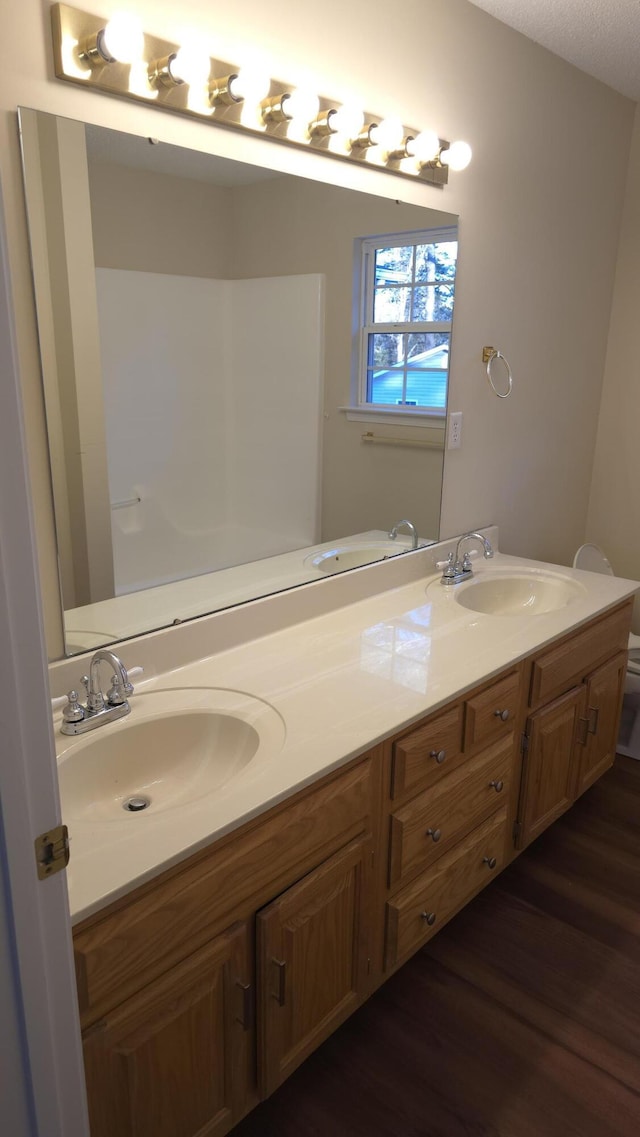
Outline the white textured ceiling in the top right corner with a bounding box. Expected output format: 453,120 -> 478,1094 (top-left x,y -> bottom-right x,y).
472,0 -> 640,102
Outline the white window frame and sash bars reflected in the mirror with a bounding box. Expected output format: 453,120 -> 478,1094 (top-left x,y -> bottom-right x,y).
342,225 -> 458,430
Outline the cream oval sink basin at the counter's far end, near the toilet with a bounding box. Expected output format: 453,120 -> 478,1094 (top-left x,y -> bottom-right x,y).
452,569 -> 587,616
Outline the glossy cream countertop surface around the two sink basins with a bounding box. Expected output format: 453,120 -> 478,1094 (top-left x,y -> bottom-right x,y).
56,545 -> 640,923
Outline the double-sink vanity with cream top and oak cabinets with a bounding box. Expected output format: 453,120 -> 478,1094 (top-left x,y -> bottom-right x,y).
51,530 -> 638,1137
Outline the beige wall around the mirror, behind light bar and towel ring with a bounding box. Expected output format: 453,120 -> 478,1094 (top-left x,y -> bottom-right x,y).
0,0 -> 633,659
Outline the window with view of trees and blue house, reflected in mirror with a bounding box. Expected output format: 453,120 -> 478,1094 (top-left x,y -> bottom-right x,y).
354,229 -> 458,420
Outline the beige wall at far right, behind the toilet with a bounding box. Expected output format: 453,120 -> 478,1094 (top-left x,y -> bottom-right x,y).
587,107 -> 640,604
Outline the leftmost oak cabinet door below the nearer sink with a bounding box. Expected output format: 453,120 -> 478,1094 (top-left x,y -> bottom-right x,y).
84,924 -> 251,1137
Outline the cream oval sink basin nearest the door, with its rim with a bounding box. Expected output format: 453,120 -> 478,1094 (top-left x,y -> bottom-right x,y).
58,687 -> 285,824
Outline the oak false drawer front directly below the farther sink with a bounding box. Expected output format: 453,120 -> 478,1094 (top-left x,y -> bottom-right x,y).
530,603 -> 631,708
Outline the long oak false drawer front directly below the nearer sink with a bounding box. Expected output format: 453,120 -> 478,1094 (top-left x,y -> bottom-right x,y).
74,757 -> 376,1026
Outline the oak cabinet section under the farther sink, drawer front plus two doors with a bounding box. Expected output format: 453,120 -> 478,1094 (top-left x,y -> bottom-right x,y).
515,604 -> 631,849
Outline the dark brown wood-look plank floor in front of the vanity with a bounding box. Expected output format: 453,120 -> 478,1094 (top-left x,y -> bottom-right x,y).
234,757 -> 640,1137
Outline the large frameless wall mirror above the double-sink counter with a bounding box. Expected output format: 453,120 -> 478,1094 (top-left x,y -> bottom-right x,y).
20,109 -> 457,655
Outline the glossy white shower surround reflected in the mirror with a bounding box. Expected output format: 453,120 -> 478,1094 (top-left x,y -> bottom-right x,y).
97,268 -> 324,596
